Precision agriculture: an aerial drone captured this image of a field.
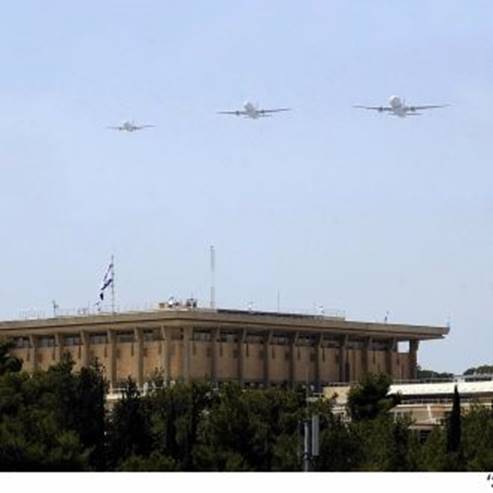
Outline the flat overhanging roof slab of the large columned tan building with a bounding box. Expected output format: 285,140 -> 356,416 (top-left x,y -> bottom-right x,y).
0,308 -> 449,340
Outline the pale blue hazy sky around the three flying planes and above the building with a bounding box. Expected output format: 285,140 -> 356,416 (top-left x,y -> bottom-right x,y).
0,0 -> 493,373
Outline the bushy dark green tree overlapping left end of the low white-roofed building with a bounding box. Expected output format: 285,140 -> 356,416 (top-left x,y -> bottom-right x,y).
347,374 -> 400,421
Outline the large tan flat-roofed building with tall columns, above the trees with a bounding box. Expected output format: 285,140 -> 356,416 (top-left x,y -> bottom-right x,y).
0,303 -> 449,390
